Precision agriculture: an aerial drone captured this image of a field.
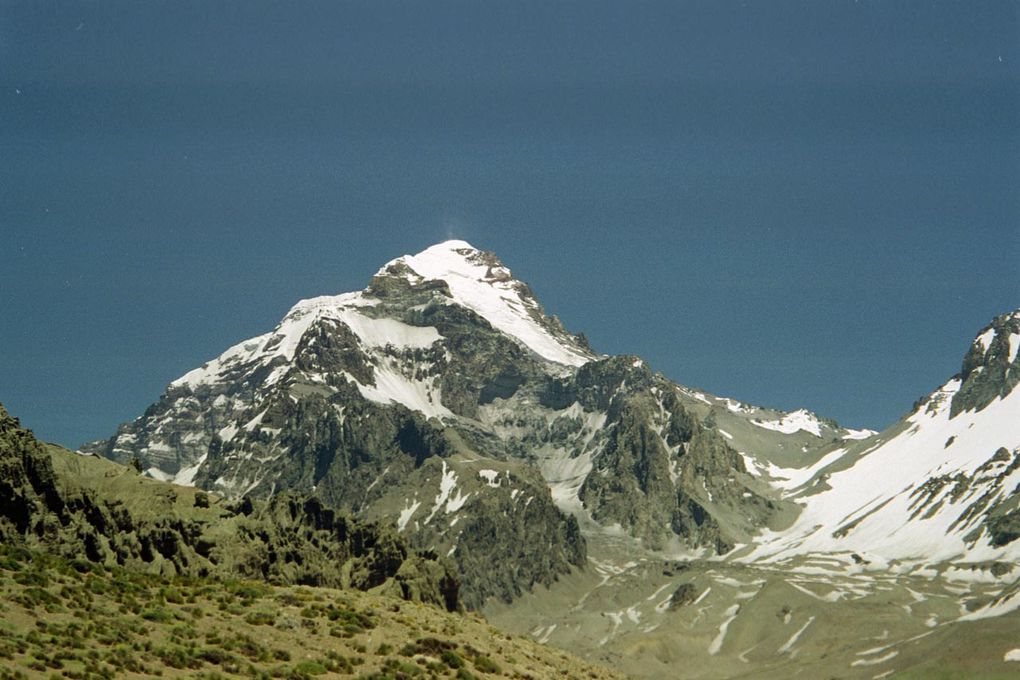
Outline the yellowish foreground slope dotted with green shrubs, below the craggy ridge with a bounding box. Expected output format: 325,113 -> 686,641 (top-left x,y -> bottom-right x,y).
0,546 -> 621,680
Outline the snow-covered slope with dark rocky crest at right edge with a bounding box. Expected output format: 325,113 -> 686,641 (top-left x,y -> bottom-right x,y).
751,311 -> 1020,576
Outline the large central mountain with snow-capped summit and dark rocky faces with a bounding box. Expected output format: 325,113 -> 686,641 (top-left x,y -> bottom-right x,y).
83,242 -> 787,605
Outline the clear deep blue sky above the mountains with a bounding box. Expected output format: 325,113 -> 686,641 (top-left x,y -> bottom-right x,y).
0,0 -> 1020,447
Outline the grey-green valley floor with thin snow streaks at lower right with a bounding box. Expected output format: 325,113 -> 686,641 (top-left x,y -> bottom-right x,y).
486,536 -> 1020,680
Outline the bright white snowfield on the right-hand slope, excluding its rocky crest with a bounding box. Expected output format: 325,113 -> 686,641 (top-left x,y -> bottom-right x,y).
751,380 -> 1020,563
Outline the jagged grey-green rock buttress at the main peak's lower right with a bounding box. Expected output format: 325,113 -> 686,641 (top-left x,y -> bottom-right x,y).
567,357 -> 775,553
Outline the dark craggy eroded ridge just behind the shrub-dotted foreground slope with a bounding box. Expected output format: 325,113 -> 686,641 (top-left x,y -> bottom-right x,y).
0,406 -> 460,611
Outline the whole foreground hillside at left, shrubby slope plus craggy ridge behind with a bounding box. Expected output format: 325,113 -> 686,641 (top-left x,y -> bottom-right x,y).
0,406 -> 619,678
